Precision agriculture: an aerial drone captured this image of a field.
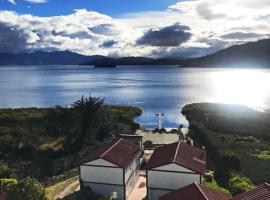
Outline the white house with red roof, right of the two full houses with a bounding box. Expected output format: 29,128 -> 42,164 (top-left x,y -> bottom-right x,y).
145,142 -> 206,200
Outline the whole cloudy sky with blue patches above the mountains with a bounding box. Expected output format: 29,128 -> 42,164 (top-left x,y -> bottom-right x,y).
0,0 -> 270,57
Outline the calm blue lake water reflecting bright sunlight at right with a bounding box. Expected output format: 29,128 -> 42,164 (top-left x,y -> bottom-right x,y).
0,66 -> 270,128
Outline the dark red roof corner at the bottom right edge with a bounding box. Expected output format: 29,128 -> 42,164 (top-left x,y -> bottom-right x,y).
231,183 -> 270,200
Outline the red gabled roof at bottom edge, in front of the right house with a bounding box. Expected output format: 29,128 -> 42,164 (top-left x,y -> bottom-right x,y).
159,183 -> 230,200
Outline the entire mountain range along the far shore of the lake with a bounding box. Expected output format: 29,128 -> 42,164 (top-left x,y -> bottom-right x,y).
0,39 -> 270,68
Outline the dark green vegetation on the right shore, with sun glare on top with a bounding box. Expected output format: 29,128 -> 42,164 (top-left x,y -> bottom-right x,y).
182,103 -> 270,194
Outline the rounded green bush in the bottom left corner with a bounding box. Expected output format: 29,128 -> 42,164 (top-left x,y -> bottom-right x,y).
5,177 -> 47,200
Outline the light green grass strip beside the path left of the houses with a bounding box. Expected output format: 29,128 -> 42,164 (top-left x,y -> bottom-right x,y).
46,176 -> 79,200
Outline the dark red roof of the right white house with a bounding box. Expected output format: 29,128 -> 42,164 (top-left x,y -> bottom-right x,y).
145,142 -> 206,174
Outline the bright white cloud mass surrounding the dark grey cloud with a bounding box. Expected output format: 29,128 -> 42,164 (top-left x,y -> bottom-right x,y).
0,0 -> 270,56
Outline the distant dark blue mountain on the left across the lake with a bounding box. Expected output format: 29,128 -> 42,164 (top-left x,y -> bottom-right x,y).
0,51 -> 104,65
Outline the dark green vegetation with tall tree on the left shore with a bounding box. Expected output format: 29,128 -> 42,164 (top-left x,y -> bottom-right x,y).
0,97 -> 141,198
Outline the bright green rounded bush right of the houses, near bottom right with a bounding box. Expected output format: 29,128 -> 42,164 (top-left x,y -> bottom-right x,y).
229,172 -> 254,195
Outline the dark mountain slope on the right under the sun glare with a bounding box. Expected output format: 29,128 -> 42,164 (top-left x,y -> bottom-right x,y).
180,39 -> 270,68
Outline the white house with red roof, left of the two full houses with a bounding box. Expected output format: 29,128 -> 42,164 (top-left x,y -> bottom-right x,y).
80,138 -> 140,200
